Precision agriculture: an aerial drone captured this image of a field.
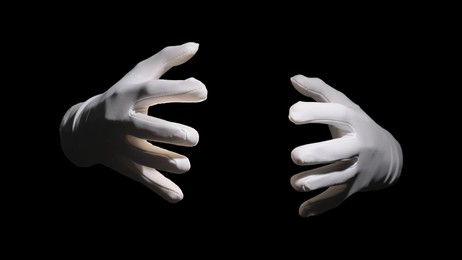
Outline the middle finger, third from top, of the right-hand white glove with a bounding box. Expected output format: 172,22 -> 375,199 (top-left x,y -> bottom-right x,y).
291,135 -> 359,165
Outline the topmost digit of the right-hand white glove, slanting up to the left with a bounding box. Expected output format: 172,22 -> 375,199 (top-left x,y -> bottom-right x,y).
290,75 -> 357,106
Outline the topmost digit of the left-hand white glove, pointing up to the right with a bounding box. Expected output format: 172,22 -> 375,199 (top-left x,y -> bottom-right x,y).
124,42 -> 199,82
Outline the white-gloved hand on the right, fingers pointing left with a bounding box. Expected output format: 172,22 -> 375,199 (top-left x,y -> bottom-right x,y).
289,75 -> 403,217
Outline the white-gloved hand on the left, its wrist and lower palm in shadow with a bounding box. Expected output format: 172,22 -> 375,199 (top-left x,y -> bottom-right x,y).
60,42 -> 207,203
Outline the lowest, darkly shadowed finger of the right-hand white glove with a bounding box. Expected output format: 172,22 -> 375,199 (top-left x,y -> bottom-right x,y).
298,183 -> 351,217
